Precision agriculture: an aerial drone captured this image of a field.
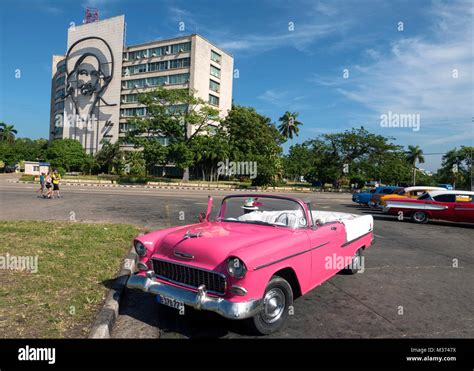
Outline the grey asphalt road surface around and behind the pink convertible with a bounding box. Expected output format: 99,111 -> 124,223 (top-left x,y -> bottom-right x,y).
0,175 -> 474,338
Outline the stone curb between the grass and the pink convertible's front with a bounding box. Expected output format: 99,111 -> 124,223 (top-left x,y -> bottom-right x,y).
88,247 -> 137,339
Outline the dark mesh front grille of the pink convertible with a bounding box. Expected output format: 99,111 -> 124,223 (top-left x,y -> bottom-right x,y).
153,259 -> 226,295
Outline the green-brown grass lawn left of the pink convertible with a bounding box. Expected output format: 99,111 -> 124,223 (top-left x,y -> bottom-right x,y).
0,221 -> 139,338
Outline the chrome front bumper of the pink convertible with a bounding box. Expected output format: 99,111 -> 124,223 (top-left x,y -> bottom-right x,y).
127,274 -> 263,319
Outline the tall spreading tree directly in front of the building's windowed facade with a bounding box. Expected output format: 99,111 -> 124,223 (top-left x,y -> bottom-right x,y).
126,87 -> 220,181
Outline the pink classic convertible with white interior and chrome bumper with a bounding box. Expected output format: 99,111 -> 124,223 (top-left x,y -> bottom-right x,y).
127,195 -> 373,334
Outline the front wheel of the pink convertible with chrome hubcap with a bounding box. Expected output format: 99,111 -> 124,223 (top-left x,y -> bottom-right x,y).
248,276 -> 293,335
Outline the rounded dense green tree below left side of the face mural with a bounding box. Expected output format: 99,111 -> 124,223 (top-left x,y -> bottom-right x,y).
46,139 -> 88,171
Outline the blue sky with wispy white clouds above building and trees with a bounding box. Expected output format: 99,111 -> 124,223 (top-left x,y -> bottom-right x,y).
0,0 -> 474,171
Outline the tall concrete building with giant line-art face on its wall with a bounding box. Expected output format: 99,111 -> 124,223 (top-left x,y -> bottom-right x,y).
50,15 -> 233,154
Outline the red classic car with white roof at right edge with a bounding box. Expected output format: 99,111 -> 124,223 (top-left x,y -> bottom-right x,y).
383,190 -> 474,223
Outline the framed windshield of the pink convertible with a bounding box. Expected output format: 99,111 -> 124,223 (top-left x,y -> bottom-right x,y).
218,196 -> 307,228
